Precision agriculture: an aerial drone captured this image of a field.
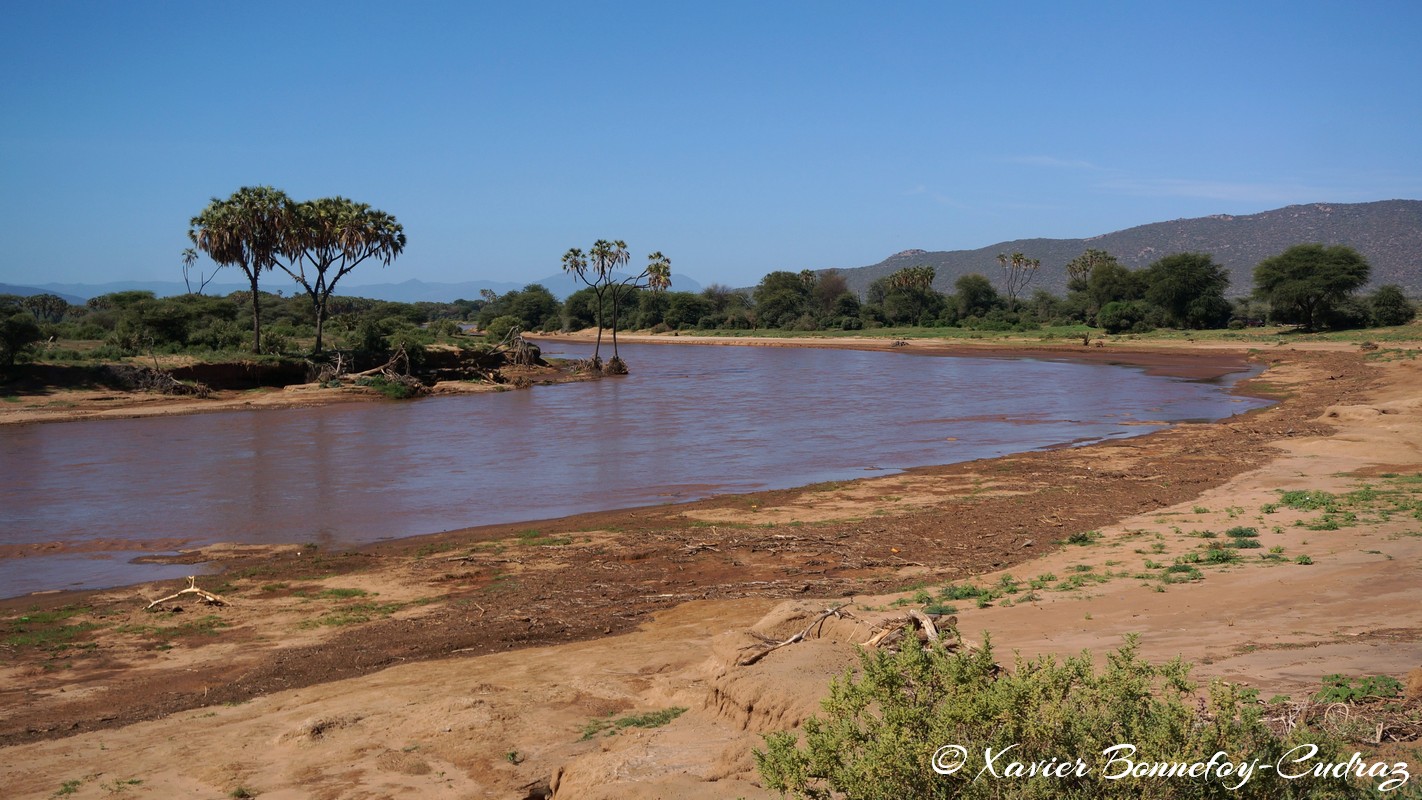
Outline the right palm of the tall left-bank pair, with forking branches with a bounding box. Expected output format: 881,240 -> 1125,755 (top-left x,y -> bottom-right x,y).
277,198 -> 405,354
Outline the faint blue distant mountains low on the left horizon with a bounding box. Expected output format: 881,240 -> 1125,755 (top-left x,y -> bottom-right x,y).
0,271 -> 701,304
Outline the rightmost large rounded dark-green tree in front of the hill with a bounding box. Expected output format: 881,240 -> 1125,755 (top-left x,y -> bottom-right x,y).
1254,244 -> 1371,331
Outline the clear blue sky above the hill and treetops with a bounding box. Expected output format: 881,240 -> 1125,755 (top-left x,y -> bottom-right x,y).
0,0 -> 1422,286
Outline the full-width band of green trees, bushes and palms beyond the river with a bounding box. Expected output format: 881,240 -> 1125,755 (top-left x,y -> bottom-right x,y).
0,237 -> 1416,368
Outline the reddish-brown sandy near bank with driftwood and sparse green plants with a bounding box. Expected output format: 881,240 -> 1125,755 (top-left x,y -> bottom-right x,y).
0,344 -> 1422,799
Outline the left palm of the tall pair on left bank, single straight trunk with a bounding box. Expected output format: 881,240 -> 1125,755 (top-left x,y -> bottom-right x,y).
188,186 -> 292,352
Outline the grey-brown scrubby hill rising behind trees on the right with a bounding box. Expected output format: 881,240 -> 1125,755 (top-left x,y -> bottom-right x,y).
839,200 -> 1422,296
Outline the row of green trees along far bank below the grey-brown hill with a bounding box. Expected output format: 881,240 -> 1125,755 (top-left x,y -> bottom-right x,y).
631,244 -> 1415,334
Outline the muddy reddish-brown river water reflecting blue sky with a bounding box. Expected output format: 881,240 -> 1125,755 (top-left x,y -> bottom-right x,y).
0,342 -> 1263,597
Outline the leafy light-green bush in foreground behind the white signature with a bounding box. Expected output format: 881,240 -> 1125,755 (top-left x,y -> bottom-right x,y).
755,635 -> 1372,800
